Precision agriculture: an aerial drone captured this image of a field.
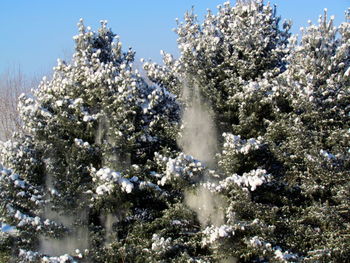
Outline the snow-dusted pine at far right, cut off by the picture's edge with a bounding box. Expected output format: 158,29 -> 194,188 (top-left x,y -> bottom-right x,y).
267,10 -> 350,262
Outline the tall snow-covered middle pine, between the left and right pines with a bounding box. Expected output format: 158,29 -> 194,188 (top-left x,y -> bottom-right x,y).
144,1 -> 295,262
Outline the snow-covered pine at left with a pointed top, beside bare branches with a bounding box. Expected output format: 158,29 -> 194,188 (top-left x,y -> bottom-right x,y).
0,21 -> 193,262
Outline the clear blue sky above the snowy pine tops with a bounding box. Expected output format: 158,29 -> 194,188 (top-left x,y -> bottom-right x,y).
0,0 -> 350,75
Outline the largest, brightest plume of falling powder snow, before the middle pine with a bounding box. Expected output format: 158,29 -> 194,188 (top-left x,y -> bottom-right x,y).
178,85 -> 225,227
